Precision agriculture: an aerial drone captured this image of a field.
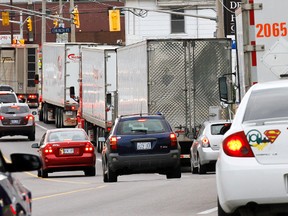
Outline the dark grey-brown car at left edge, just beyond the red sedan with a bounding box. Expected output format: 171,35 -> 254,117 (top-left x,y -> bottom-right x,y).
0,103 -> 36,141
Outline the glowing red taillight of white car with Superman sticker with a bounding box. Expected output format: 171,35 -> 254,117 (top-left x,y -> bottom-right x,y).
223,131 -> 254,157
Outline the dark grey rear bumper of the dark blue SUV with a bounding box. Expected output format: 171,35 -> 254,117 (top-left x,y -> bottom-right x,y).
108,150 -> 180,175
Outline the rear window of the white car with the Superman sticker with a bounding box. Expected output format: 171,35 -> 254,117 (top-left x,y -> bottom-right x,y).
244,88 -> 288,121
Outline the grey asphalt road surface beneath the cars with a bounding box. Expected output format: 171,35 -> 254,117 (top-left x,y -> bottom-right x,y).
0,115 -> 217,216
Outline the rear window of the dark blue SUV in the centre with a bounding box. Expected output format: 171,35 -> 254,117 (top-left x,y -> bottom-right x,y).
117,118 -> 169,135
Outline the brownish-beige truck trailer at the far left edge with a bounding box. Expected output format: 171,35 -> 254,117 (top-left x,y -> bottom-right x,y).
0,44 -> 39,107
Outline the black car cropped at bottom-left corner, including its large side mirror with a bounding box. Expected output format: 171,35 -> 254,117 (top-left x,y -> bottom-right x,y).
0,151 -> 41,215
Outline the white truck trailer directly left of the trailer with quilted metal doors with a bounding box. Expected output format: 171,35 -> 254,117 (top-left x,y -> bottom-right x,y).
78,45 -> 119,152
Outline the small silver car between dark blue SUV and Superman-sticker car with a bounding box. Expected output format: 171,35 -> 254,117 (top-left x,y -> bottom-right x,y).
190,120 -> 231,174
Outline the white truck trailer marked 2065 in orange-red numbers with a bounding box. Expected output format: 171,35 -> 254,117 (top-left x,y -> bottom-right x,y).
236,0 -> 288,98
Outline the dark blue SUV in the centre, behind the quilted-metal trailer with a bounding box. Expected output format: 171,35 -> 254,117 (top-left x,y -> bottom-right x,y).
102,114 -> 181,182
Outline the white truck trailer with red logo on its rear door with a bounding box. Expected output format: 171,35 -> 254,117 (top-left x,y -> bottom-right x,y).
39,43 -> 96,128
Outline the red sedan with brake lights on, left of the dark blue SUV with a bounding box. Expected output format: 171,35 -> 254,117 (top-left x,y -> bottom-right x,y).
31,128 -> 96,178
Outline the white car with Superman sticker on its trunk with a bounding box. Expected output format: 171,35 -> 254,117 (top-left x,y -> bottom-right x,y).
216,80 -> 288,216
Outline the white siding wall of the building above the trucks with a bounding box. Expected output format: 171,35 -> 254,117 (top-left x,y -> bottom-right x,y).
125,0 -> 216,45
